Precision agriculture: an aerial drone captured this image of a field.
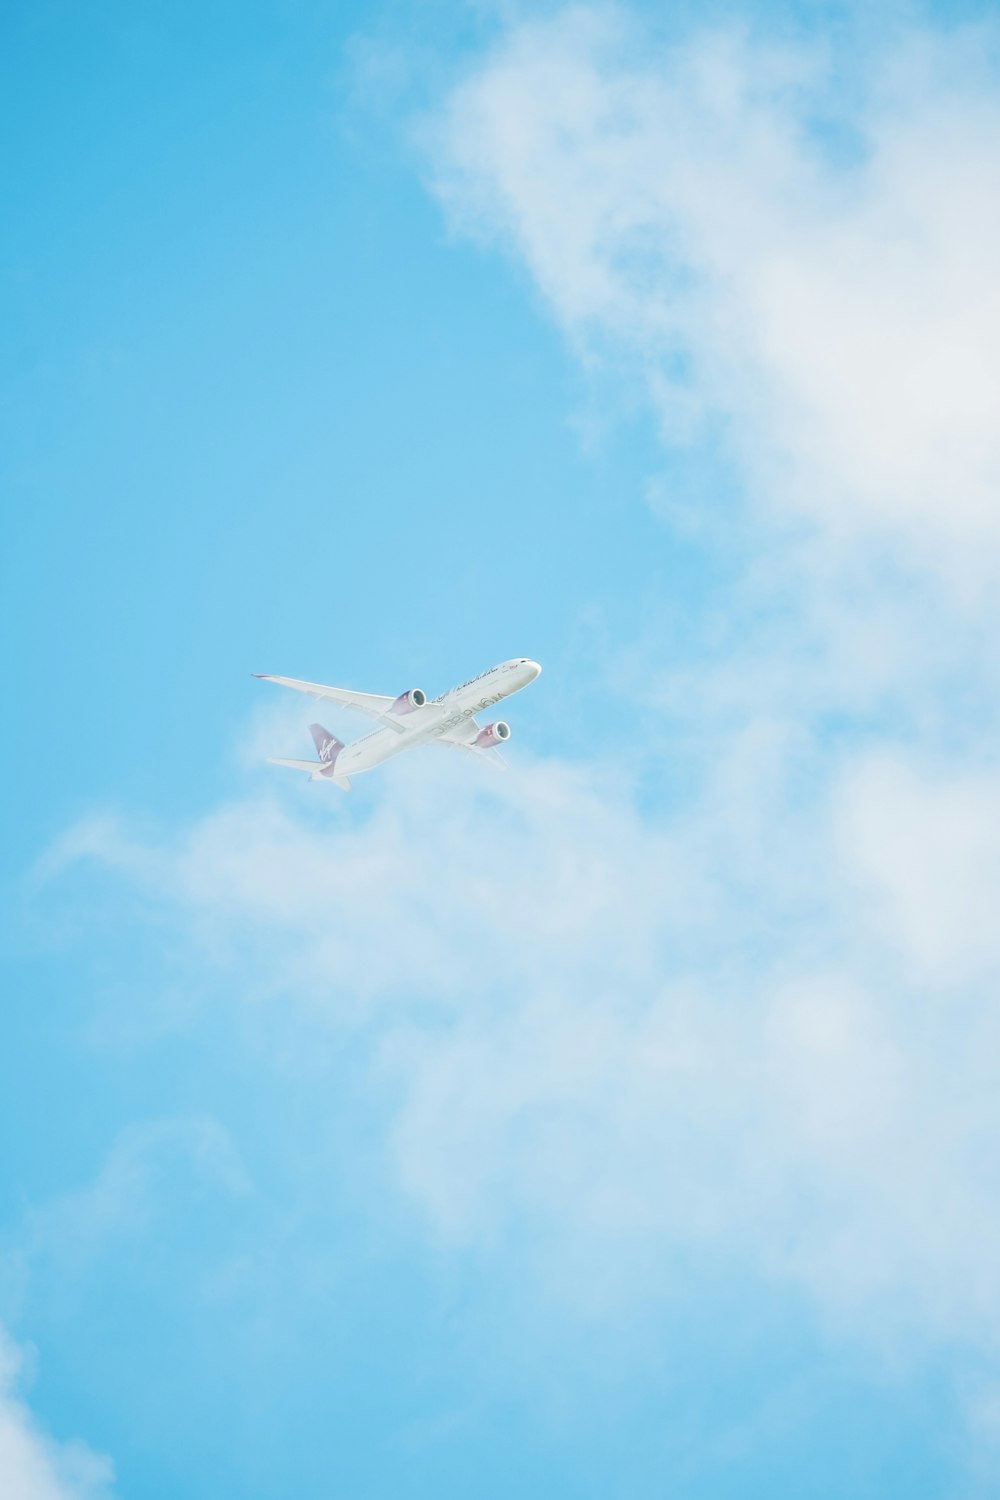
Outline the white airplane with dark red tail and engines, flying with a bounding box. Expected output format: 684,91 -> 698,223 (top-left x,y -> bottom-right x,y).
253,657 -> 541,792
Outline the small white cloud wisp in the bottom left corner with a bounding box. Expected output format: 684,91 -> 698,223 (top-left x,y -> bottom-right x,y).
0,1329 -> 114,1500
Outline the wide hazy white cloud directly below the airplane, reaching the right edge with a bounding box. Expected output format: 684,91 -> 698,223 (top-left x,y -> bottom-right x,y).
44,737 -> 1000,1343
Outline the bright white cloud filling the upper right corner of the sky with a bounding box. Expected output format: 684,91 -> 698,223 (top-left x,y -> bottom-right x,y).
426,8 -> 1000,587
